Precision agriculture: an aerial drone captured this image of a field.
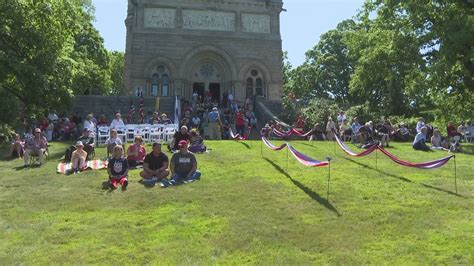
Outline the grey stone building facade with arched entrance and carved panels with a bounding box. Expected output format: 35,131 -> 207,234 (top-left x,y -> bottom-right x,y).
125,0 -> 283,104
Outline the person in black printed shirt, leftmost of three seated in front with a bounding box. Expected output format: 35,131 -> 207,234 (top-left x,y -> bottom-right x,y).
107,145 -> 128,191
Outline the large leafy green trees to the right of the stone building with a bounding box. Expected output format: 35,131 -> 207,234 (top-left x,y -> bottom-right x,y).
285,0 -> 474,124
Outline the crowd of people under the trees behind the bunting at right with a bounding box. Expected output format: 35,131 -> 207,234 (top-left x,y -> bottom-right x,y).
262,111 -> 474,152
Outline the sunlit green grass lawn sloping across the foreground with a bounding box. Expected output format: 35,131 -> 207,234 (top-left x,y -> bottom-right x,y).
0,141 -> 474,265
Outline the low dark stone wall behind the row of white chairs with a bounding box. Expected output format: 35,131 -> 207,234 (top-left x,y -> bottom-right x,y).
71,95 -> 175,121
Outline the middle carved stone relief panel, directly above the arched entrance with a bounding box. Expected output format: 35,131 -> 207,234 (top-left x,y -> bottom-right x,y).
183,10 -> 235,31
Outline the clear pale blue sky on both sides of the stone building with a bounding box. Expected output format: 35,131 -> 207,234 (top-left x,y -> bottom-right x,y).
93,0 -> 364,66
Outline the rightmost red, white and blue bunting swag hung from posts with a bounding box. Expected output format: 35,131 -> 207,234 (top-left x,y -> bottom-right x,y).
336,135 -> 458,193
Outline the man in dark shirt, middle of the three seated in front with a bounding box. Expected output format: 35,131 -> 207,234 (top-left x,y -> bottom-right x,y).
140,142 -> 170,186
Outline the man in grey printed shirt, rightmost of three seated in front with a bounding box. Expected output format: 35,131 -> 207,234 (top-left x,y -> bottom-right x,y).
162,140 -> 201,187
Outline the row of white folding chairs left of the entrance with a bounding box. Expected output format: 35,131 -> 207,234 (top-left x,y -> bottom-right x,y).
96,124 -> 178,145
